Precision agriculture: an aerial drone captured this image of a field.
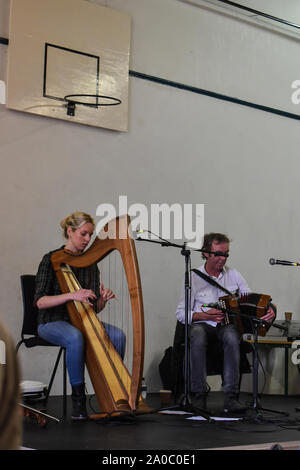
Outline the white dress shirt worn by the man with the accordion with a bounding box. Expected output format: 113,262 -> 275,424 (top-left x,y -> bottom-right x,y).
176,264 -> 251,326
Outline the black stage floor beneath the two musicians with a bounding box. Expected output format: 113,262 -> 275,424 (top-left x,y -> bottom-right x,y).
23,392 -> 300,453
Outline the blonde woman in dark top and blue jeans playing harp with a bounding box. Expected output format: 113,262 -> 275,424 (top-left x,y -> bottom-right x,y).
35,212 -> 126,420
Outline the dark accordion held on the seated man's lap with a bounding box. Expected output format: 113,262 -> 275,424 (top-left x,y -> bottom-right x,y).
219,292 -> 272,336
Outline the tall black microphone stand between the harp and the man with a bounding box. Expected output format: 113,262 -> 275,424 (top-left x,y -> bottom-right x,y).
136,232 -> 214,423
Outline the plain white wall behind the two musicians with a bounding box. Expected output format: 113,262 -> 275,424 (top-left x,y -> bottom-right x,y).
0,0 -> 300,394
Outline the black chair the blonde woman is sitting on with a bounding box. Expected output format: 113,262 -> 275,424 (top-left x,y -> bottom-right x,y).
16,274 -> 67,416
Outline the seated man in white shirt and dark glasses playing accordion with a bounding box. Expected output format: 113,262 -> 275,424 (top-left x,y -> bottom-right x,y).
176,233 -> 275,412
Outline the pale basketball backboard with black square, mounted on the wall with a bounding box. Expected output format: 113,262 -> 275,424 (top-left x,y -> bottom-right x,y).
7,0 -> 130,131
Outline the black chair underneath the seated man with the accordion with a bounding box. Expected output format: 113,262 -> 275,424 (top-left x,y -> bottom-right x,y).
171,321 -> 252,398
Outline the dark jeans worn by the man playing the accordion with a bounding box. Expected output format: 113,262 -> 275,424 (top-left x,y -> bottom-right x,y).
190,323 -> 240,393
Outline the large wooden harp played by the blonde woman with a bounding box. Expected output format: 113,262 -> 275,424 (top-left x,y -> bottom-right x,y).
51,215 -> 146,414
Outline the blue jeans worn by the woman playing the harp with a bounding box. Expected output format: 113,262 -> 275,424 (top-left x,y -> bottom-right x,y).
38,321 -> 126,385
